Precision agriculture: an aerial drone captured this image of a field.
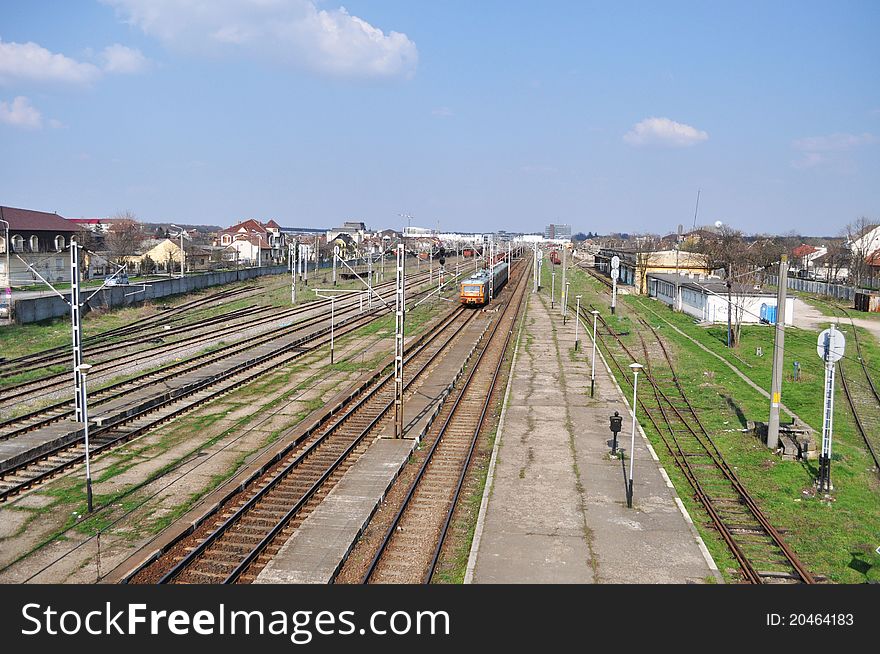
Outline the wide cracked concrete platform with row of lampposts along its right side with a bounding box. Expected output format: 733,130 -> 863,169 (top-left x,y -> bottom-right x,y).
465,294 -> 722,583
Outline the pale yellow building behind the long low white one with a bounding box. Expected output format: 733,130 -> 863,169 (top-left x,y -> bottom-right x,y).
594,247 -> 711,293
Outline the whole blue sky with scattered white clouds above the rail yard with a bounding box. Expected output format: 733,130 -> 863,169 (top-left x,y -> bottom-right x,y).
0,0 -> 880,235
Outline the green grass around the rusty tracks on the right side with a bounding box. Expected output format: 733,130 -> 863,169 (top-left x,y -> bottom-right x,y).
545,262 -> 880,583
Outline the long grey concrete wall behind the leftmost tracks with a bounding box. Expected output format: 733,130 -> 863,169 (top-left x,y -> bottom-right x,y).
13,266 -> 287,324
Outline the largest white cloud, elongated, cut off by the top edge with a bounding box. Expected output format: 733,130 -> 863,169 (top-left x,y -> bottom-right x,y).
102,0 -> 418,77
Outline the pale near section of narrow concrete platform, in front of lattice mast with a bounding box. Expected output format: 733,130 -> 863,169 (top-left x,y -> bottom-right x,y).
254,439 -> 416,584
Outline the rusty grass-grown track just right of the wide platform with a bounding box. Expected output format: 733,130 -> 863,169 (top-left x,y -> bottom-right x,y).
581,307 -> 815,584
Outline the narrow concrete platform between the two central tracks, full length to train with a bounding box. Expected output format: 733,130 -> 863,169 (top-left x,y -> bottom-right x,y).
255,314 -> 496,584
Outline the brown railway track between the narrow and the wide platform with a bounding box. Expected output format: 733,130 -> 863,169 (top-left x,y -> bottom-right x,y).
361,258 -> 528,584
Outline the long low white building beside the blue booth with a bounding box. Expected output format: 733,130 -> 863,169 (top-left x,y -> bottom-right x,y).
647,273 -> 794,325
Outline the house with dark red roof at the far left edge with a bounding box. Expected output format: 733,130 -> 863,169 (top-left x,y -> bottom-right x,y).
0,206 -> 79,286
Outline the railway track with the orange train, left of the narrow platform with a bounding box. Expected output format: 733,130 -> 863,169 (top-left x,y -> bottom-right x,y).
125,307 -> 476,583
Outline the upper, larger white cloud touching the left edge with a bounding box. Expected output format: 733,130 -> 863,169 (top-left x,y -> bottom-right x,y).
0,41 -> 101,84
